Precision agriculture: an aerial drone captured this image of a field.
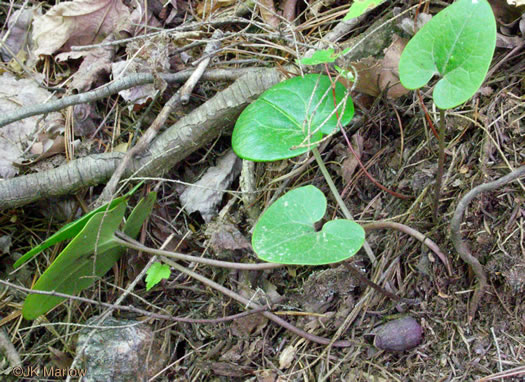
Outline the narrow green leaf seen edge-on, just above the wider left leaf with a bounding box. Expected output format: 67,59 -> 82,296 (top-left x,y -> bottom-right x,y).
13,182 -> 144,269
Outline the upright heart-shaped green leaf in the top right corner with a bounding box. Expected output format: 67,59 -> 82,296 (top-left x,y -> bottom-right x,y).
399,0 -> 496,109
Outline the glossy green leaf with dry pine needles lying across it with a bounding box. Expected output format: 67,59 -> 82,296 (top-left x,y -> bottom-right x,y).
232,74 -> 354,162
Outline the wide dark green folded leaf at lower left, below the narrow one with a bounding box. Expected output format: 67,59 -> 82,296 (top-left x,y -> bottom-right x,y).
22,203 -> 126,320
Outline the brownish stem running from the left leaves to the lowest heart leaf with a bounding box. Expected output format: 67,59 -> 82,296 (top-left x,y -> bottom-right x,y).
114,231 -> 283,271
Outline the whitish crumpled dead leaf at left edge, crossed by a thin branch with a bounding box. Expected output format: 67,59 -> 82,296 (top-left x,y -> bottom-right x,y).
0,72 -> 62,178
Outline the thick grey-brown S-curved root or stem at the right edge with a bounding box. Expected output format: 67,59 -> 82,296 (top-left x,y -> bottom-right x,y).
450,166 -> 525,322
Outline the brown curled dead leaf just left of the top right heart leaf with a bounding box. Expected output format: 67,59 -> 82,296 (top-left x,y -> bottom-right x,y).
340,35 -> 408,99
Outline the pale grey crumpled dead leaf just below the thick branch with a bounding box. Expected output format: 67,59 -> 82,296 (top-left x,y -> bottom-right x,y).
180,150 -> 241,222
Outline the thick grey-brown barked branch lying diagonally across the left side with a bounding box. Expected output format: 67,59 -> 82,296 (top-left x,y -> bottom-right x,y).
0,69 -> 282,210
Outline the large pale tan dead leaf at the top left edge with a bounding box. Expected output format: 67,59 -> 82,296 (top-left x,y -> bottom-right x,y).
33,0 -> 130,58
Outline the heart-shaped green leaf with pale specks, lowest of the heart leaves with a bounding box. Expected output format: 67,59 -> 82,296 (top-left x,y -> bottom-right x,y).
252,186 -> 365,265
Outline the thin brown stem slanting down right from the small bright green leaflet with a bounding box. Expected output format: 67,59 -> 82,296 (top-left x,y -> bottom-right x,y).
161,259 -> 352,347
